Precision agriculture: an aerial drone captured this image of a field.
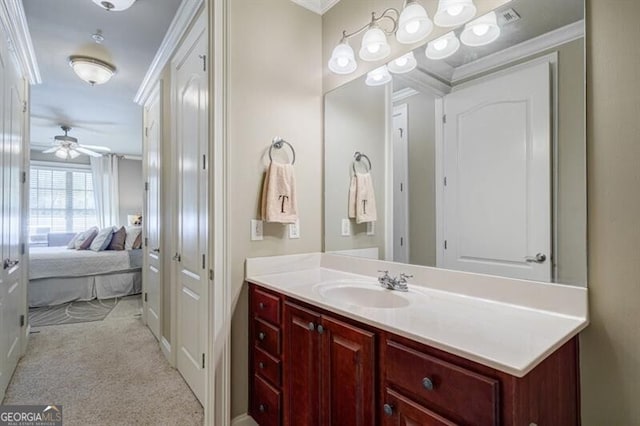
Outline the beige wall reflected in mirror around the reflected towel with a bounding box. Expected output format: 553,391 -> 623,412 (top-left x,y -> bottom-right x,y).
324,78 -> 388,259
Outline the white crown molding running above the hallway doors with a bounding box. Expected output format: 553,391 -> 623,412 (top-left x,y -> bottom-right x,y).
134,0 -> 204,105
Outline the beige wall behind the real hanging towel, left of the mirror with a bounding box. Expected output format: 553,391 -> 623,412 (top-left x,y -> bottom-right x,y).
228,0 -> 322,416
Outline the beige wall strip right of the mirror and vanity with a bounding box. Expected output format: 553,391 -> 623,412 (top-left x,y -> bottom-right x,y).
580,0 -> 640,426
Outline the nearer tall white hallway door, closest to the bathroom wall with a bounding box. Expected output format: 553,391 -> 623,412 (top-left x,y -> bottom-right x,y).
173,18 -> 209,402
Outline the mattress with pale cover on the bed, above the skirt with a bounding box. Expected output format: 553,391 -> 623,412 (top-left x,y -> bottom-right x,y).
29,247 -> 142,280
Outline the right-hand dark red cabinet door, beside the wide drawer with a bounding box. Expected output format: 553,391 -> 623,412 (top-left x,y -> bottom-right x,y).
319,316 -> 376,426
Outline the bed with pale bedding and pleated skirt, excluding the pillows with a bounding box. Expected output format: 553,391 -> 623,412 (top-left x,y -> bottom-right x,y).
28,247 -> 142,307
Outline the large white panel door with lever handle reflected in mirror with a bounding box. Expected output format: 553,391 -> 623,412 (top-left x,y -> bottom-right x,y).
438,59 -> 552,281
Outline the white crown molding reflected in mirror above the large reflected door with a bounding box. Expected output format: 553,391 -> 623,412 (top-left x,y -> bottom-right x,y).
451,20 -> 584,84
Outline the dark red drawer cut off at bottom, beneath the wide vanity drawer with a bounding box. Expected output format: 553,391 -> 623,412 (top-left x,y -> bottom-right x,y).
381,388 -> 456,426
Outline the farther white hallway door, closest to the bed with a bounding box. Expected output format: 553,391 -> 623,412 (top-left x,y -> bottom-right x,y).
143,85 -> 162,340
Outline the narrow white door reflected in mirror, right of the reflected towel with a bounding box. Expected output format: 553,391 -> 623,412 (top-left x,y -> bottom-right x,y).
391,104 -> 409,263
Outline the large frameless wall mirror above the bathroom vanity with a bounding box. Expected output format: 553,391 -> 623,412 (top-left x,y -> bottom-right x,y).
324,0 -> 587,286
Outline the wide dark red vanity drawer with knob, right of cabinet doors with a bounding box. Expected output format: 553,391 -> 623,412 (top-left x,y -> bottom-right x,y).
385,340 -> 499,426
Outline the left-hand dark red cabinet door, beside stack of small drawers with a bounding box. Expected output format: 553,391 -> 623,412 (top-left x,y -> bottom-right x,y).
283,302 -> 320,426
